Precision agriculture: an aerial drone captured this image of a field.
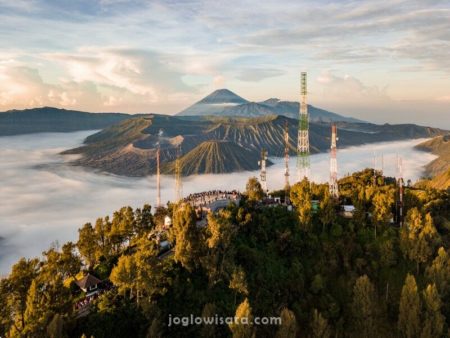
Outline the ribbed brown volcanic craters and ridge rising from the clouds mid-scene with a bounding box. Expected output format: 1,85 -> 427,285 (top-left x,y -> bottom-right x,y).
65,114 -> 445,176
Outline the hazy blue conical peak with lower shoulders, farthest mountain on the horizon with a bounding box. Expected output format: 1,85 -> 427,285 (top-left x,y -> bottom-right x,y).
177,89 -> 364,122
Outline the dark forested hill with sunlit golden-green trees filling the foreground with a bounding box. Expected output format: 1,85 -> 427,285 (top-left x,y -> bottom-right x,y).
0,169 -> 450,338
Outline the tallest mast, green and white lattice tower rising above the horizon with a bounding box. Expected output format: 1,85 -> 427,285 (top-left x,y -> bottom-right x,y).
297,72 -> 309,180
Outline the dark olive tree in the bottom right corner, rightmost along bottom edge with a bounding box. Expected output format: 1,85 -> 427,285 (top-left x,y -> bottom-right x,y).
420,284 -> 445,338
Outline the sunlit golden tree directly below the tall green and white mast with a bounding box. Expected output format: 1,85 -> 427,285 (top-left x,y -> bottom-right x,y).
291,178 -> 312,230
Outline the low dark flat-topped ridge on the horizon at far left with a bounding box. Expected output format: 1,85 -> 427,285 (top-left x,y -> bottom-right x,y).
0,107 -> 133,136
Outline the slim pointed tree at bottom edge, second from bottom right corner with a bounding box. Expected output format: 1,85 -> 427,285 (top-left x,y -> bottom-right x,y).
398,274 -> 421,338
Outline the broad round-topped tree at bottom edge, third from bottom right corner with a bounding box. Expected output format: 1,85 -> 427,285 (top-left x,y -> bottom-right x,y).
352,275 -> 380,338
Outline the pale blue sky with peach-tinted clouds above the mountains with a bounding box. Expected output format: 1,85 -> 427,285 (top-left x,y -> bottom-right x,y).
0,0 -> 450,128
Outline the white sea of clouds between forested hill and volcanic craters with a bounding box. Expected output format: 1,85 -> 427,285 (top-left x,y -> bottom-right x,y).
0,131 -> 435,275
